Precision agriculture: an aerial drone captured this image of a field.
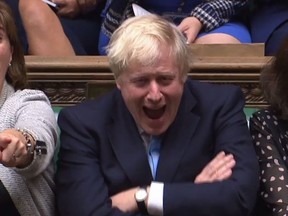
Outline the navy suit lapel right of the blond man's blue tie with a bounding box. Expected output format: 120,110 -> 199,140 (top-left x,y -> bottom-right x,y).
156,85 -> 200,182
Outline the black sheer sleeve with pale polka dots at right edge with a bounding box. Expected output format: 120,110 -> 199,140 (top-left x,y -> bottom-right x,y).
250,111 -> 288,216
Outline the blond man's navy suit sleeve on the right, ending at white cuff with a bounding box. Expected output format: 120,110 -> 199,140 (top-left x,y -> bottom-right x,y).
163,88 -> 259,216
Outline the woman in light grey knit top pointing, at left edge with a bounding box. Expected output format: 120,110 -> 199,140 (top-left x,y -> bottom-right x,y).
0,1 -> 57,216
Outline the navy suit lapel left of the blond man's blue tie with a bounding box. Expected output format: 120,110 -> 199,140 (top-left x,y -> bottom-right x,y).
108,94 -> 152,185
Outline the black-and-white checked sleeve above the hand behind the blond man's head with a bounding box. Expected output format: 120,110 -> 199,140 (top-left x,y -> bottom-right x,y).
191,0 -> 248,31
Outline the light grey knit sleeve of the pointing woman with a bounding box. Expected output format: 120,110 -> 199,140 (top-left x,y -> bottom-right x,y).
8,89 -> 57,179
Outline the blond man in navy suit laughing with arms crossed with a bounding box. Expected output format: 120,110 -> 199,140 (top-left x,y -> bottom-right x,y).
56,15 -> 259,216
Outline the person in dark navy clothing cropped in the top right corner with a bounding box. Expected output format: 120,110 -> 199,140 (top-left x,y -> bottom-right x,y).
250,0 -> 288,56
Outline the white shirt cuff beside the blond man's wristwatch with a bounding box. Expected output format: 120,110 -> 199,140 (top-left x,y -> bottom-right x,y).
147,182 -> 164,215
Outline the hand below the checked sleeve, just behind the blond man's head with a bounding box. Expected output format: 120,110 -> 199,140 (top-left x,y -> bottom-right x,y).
178,17 -> 202,44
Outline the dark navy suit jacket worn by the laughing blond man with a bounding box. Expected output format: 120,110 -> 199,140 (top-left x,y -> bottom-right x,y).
56,81 -> 258,216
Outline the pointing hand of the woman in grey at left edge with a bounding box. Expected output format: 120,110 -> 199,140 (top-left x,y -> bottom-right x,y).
0,129 -> 33,168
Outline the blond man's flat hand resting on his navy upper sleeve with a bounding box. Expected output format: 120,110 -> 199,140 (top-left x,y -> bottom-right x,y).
194,151 -> 236,183
